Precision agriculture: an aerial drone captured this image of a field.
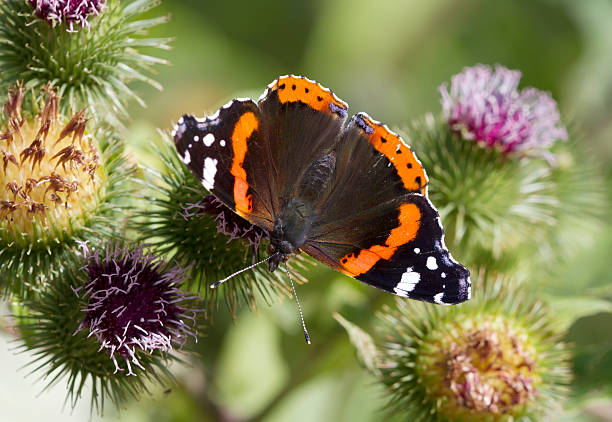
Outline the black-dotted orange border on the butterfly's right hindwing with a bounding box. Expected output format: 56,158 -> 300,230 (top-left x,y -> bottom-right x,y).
356,113 -> 427,195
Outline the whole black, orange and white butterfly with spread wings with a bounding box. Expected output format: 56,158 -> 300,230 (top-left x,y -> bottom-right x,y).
173,76 -> 470,304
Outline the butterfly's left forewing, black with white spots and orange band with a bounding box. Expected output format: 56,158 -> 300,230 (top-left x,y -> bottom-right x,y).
174,99 -> 273,230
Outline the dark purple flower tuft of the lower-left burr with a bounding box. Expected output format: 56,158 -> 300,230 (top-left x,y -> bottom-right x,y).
74,243 -> 197,375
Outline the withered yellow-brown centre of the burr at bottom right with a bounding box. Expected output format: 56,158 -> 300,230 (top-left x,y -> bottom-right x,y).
417,318 -> 542,418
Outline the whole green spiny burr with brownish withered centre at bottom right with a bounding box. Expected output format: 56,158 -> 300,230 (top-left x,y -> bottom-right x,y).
342,272 -> 570,422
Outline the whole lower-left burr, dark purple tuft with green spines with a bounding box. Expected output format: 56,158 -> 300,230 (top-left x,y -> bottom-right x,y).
16,243 -> 195,412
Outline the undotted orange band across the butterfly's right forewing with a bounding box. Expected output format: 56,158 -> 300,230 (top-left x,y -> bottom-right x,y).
339,204 -> 421,277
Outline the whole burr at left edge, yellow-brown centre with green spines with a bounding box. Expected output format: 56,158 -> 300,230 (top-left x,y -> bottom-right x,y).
0,87 -> 131,294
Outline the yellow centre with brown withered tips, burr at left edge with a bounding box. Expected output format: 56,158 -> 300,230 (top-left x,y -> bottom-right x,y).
0,86 -> 99,244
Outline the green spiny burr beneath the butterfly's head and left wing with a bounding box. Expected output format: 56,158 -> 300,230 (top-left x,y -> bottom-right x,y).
136,133 -> 302,318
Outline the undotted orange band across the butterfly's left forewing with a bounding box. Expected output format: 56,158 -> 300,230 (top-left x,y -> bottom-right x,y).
230,112 -> 259,216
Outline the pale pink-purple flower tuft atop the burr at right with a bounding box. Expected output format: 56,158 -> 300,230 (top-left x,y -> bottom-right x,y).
440,65 -> 567,156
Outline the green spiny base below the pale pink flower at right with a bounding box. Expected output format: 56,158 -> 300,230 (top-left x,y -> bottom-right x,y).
405,115 -> 559,269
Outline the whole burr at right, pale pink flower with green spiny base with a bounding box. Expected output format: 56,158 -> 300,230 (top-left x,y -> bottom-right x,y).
406,66 -> 567,269
